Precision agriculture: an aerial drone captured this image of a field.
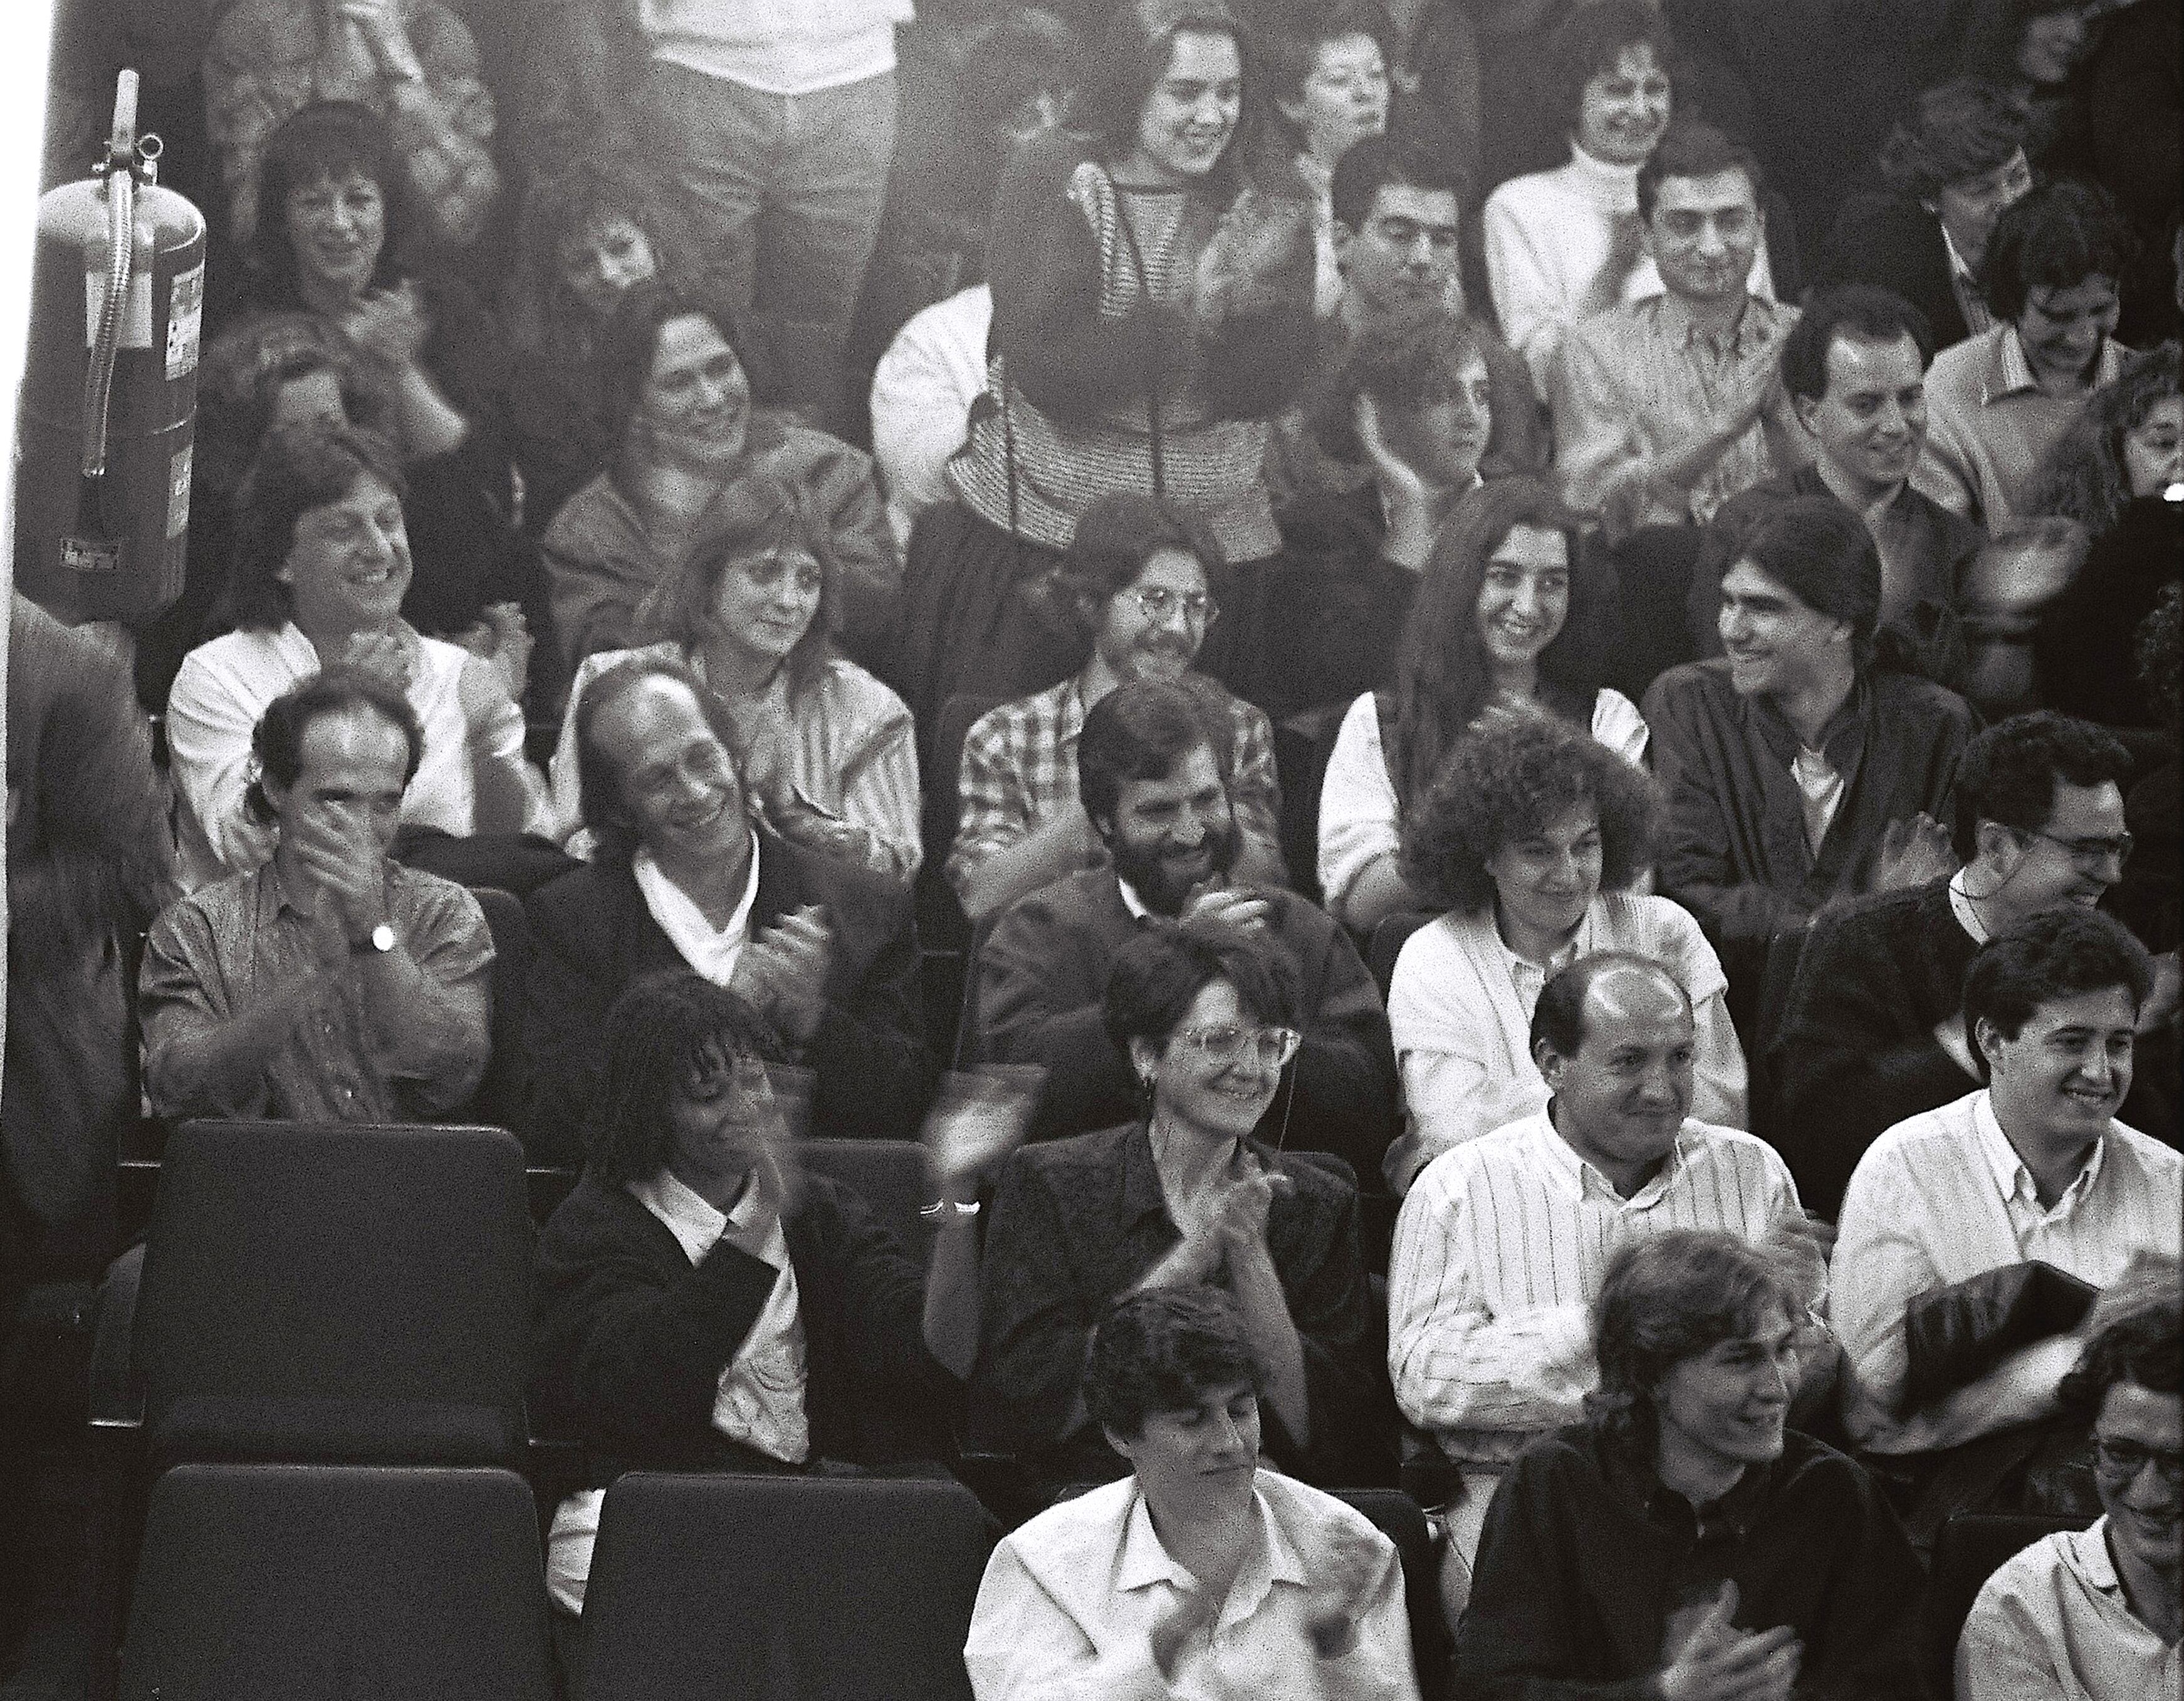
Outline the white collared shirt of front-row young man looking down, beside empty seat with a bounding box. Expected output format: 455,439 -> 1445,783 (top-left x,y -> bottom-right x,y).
963,1467 -> 1418,1701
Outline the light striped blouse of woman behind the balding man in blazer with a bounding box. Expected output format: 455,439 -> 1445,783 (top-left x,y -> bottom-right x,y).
546,640 -> 922,882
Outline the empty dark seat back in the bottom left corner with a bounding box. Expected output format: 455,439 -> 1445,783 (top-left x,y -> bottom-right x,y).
120,1465 -> 555,1701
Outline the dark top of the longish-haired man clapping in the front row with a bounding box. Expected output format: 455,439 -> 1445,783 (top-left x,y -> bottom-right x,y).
1455,1428 -> 1926,1701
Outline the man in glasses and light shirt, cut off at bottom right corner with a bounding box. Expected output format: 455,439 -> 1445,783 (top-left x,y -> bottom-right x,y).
1957,1260 -> 2184,1701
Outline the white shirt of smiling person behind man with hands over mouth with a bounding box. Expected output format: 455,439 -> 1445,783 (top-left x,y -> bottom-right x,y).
166,622 -> 546,891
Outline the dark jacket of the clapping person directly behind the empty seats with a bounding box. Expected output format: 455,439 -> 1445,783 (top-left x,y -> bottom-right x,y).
531,1175 -> 959,1487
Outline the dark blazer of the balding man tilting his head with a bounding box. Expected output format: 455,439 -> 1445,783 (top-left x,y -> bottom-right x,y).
524,828 -> 933,1162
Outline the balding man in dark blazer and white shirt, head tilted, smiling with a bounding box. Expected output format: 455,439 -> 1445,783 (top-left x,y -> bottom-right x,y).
524,655 -> 931,1162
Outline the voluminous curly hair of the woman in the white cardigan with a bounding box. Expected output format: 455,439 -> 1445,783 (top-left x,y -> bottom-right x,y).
1402,714 -> 1660,915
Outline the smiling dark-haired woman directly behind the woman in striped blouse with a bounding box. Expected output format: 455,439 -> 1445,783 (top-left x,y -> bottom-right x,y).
544,284 -> 902,666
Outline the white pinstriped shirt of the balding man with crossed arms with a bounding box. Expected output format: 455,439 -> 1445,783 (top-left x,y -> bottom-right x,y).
1387,1110 -> 1800,1463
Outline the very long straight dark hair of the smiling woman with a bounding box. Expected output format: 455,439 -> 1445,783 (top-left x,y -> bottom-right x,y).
1387,476 -> 1616,804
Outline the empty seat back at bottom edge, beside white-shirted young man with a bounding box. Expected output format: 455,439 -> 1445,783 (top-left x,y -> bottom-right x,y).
581,1472 -> 994,1701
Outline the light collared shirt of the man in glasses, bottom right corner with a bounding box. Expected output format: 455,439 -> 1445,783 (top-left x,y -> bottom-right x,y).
1957,1517 -> 2184,1701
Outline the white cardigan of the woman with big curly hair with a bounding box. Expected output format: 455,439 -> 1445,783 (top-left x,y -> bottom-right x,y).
1384,891 -> 1747,1192
